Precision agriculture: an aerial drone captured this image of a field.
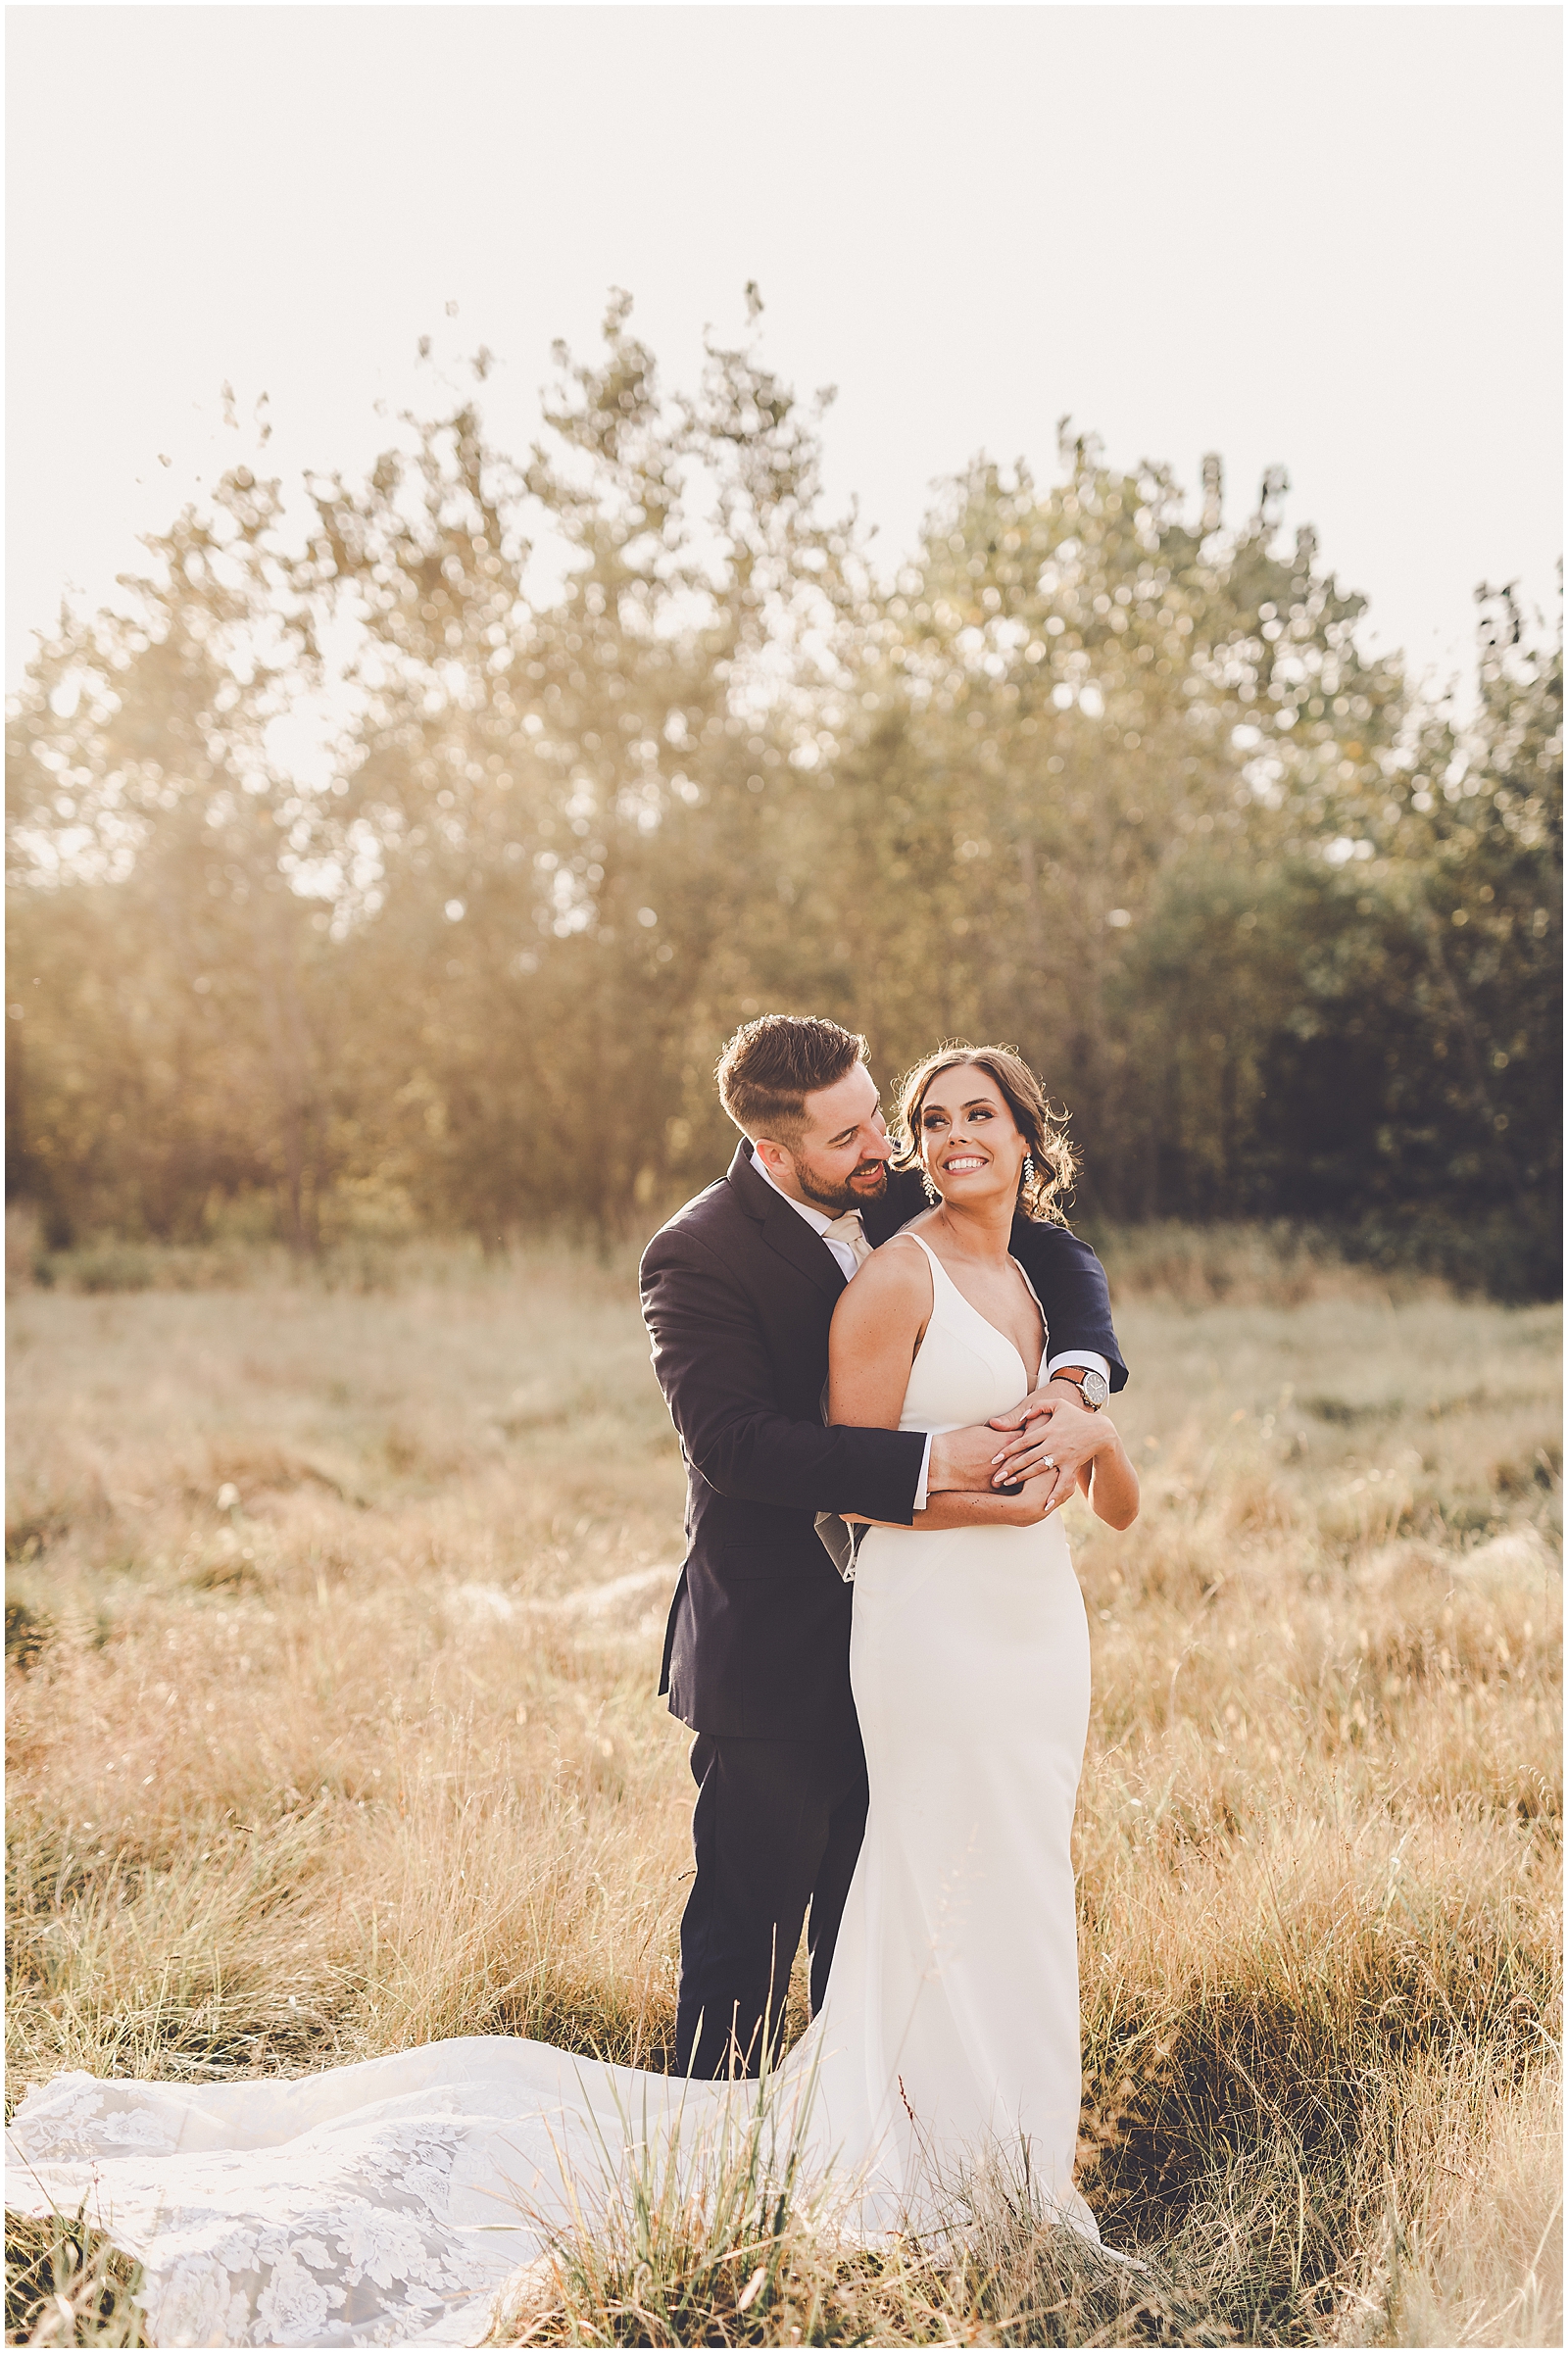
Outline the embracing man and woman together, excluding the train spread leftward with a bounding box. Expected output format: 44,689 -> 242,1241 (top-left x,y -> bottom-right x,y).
643,1014 -> 1137,2230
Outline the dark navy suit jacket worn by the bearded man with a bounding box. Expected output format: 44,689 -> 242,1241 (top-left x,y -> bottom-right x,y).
643,1144 -> 1128,1739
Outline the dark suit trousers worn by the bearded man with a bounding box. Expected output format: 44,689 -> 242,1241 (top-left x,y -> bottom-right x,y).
675,1723 -> 866,2076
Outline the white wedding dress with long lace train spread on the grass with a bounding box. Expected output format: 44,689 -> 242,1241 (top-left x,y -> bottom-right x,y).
7,1236 -> 1098,2346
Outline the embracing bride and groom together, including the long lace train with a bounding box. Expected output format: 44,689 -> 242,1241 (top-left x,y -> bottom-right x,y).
7,1016 -> 1137,2346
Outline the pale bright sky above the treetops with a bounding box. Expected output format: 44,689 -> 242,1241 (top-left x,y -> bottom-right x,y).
7,5 -> 1561,680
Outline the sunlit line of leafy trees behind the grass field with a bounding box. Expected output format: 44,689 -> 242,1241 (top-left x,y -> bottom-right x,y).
7,297 -> 1561,1297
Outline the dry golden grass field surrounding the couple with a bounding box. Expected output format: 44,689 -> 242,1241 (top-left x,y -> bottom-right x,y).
7,1245 -> 1561,2346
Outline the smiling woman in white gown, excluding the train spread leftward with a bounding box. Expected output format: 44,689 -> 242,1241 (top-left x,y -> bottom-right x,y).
814,1047 -> 1137,2235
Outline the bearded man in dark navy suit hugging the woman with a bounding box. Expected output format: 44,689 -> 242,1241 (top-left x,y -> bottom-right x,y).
643,1014 -> 1128,2076
